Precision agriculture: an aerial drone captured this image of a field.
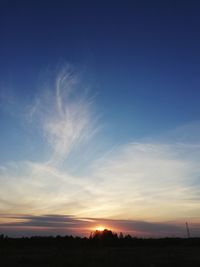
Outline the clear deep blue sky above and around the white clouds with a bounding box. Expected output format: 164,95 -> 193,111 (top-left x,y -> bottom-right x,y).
0,0 -> 200,161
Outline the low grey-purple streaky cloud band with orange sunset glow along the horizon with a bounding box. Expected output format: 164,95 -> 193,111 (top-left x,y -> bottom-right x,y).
0,214 -> 200,237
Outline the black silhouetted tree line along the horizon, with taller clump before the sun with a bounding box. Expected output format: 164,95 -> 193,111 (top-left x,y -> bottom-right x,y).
0,229 -> 200,248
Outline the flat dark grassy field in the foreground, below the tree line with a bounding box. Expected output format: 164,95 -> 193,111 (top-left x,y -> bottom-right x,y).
0,246 -> 200,267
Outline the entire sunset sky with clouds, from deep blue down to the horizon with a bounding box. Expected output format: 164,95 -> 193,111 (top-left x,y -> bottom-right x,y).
0,0 -> 200,237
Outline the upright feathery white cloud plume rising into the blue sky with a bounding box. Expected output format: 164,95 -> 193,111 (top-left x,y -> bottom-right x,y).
29,66 -> 100,164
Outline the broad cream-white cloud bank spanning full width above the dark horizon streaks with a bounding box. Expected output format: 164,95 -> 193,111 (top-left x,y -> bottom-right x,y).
0,126 -> 200,227
